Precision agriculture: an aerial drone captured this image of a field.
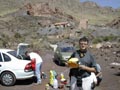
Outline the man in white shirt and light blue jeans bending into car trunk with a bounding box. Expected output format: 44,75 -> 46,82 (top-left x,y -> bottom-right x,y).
29,52 -> 43,84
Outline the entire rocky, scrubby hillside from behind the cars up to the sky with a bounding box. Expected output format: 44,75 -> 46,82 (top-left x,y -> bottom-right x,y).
0,0 -> 120,48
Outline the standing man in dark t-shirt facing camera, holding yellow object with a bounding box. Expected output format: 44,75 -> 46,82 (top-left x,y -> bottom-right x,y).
69,37 -> 96,90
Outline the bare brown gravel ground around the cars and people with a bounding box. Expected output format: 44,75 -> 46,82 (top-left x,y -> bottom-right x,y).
0,48 -> 120,90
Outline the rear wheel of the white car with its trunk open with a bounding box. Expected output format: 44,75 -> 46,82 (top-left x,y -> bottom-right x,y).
0,72 -> 16,86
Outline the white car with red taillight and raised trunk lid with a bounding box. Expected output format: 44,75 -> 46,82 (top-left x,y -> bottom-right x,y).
0,49 -> 34,86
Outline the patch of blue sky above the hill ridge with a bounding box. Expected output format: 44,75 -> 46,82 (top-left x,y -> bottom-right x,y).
80,0 -> 120,9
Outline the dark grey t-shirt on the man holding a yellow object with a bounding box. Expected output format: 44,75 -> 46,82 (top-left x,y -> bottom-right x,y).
69,50 -> 96,78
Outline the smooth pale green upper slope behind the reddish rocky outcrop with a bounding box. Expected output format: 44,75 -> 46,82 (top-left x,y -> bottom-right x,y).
0,0 -> 120,24
